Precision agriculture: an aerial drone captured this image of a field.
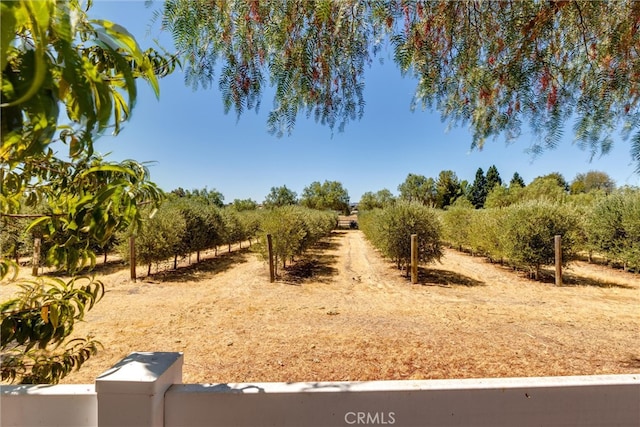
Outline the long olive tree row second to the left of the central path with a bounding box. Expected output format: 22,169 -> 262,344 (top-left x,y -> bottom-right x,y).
118,198 -> 260,273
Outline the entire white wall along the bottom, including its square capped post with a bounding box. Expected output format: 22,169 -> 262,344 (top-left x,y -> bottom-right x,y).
0,353 -> 640,427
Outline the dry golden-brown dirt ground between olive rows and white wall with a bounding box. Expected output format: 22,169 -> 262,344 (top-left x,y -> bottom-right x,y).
2,230 -> 640,383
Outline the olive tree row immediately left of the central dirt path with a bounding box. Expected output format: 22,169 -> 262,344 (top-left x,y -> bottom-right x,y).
256,205 -> 338,274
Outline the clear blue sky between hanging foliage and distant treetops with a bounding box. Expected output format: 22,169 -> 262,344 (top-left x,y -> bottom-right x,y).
89,0 -> 640,202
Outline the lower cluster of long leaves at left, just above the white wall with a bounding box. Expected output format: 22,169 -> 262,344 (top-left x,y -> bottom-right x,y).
0,277 -> 104,384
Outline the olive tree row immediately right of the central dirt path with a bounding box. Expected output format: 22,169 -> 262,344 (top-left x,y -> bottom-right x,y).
358,201 -> 442,274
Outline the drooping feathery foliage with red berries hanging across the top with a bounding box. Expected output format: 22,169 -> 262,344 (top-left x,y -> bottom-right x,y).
159,0 -> 640,168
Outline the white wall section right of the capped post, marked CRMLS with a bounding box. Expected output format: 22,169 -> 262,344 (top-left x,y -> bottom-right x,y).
165,375 -> 640,427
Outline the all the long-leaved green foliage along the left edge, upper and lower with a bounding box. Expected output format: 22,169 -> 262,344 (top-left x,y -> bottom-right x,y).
0,0 -> 176,383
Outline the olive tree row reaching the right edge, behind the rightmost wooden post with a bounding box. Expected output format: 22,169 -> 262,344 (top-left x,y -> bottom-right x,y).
442,191 -> 640,277
